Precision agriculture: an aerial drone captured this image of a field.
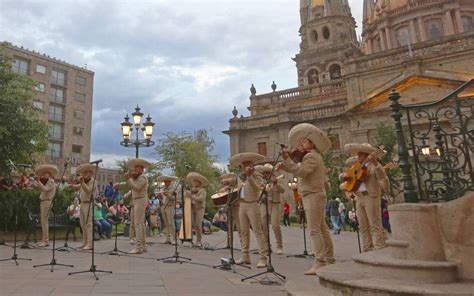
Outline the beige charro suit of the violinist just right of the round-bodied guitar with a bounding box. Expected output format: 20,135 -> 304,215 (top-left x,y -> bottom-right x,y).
239,172 -> 268,261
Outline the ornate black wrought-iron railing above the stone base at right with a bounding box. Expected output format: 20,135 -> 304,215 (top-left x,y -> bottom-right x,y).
390,79 -> 474,202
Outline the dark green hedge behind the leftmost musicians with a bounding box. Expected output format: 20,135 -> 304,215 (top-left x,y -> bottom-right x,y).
0,189 -> 74,232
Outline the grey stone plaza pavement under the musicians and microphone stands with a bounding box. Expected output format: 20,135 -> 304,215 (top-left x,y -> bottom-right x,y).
0,227 -> 358,296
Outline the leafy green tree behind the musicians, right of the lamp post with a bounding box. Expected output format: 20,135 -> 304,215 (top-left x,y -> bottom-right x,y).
156,129 -> 222,214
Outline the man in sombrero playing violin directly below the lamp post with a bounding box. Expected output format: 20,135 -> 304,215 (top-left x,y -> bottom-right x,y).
115,158 -> 151,254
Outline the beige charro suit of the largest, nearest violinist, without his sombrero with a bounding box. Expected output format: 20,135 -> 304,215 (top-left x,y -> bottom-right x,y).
282,150 -> 335,265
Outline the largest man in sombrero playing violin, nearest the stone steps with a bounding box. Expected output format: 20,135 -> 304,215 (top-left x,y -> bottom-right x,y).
277,123 -> 335,275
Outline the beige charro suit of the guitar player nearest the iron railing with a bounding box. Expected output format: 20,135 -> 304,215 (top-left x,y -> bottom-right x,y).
354,162 -> 390,252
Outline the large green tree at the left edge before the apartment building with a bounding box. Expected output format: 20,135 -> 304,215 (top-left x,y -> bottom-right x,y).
0,46 -> 48,175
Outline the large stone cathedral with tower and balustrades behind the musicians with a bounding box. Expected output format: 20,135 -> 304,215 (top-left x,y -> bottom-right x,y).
224,0 -> 474,161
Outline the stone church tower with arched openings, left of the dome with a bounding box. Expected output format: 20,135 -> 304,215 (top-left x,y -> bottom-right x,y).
294,0 -> 360,86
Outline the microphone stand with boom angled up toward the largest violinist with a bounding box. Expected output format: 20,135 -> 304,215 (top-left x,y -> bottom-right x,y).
241,145 -> 286,285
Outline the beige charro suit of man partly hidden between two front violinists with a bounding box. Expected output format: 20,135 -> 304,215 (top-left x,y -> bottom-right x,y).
260,180 -> 285,248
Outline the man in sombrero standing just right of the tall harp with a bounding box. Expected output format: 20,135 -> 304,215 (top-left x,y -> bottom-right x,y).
186,172 -> 209,247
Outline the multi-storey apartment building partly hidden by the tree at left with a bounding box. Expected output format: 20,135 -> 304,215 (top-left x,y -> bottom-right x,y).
3,42 -> 94,175
